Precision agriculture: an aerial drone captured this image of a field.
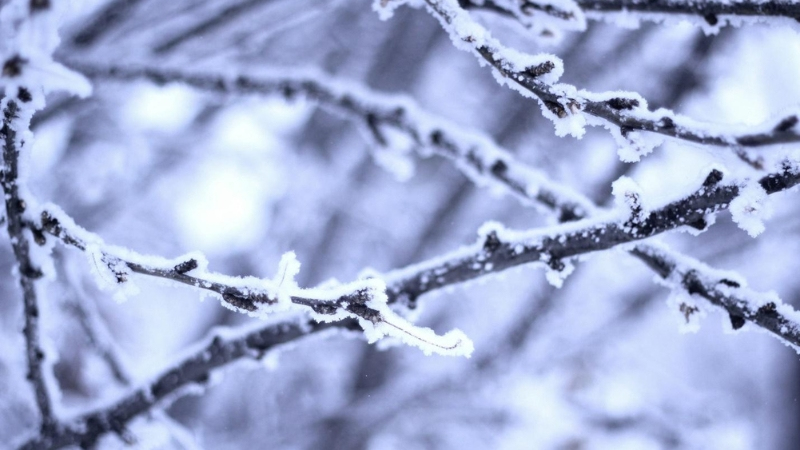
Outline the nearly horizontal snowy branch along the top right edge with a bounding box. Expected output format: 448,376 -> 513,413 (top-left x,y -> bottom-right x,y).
459,0 -> 800,26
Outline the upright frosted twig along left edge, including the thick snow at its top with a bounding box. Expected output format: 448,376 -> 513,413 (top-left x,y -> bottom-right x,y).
0,0 -> 91,432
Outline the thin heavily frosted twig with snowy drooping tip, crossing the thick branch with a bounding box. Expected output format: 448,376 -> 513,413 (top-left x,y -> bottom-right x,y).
37,205 -> 472,356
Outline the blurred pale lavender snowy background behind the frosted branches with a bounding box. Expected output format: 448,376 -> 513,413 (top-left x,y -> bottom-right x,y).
0,0 -> 800,450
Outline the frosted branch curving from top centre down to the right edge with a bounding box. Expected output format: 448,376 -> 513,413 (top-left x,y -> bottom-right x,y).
375,0 -> 800,162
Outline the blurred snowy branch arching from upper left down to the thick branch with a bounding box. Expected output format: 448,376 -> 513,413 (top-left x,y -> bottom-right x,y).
72,62 -> 593,221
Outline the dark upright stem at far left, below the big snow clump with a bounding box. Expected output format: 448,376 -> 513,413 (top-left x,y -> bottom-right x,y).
0,97 -> 56,432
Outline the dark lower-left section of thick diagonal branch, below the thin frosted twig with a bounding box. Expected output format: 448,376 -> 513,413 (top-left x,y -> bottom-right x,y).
20,319 -> 360,450
